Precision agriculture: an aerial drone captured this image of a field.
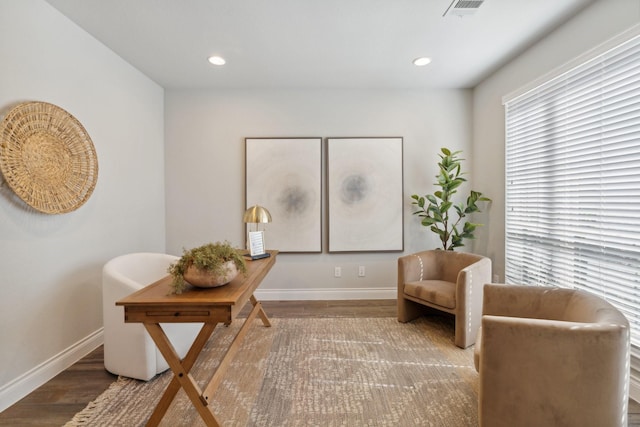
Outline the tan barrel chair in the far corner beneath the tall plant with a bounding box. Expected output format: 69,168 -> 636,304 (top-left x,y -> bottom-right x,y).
398,250 -> 491,348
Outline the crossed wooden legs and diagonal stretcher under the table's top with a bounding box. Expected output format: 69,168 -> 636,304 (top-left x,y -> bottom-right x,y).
144,295 -> 271,427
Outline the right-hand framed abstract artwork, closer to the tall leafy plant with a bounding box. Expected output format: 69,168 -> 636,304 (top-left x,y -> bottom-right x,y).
327,137 -> 404,252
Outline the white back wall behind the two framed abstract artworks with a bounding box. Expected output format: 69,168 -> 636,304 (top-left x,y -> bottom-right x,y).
165,89 -> 471,299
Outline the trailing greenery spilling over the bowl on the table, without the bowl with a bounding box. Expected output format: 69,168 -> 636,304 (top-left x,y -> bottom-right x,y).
168,240 -> 247,294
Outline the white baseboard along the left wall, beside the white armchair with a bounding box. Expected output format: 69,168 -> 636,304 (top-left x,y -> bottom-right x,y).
0,328 -> 104,412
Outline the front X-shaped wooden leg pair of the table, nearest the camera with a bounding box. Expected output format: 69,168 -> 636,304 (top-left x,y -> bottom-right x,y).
144,323 -> 220,427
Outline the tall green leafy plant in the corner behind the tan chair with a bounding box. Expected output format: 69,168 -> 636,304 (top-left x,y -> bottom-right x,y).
411,148 -> 491,251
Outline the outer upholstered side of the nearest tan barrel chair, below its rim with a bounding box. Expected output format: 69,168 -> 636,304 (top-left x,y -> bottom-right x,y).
479,315 -> 629,426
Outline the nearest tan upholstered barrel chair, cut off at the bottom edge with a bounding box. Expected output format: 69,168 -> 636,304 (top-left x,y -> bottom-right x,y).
474,284 -> 630,427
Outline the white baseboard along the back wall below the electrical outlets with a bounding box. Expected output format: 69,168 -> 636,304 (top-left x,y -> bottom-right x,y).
255,287 -> 398,301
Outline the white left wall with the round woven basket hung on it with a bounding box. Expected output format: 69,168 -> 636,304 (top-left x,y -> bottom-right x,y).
0,0 -> 165,410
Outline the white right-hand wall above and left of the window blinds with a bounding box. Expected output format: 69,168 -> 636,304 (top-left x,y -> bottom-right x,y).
473,0 -> 640,281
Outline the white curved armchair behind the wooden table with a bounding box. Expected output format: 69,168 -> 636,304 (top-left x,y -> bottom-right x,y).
102,253 -> 202,381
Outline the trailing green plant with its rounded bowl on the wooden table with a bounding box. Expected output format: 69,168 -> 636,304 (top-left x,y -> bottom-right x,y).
168,241 -> 247,294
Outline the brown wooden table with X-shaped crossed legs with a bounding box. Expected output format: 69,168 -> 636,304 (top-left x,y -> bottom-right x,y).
116,251 -> 278,427
